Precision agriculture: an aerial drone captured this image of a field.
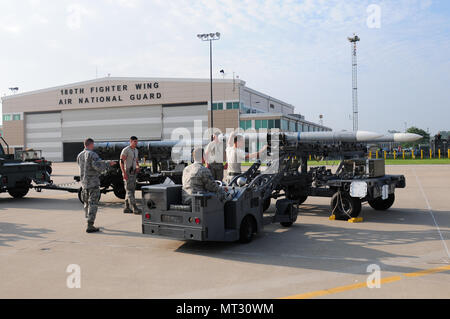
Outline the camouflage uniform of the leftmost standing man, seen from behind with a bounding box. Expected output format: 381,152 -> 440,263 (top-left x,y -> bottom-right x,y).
77,149 -> 109,225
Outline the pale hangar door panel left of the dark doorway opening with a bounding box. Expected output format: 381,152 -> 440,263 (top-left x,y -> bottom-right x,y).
25,112 -> 63,162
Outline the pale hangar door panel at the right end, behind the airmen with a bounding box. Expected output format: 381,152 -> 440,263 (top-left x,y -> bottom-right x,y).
163,103 -> 208,140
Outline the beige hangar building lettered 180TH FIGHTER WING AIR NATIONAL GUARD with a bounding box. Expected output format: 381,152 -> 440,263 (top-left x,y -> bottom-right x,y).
2,77 -> 331,161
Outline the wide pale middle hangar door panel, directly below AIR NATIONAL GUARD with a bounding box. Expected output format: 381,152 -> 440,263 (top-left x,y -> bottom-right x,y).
62,105 -> 162,143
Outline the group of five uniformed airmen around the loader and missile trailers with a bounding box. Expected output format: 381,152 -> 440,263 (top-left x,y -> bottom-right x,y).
77,133 -> 267,233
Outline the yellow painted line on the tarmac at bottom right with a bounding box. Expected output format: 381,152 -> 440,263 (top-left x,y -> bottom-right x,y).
280,266 -> 450,299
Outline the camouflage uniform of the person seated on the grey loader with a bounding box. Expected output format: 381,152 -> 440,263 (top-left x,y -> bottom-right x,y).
183,163 -> 226,205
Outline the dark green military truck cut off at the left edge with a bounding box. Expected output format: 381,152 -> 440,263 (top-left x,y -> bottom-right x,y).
0,137 -> 50,198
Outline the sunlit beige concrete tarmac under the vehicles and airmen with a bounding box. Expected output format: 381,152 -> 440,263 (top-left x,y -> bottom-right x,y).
0,163 -> 450,299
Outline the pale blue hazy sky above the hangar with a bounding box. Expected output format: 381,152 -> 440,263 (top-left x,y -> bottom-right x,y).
0,0 -> 450,133
